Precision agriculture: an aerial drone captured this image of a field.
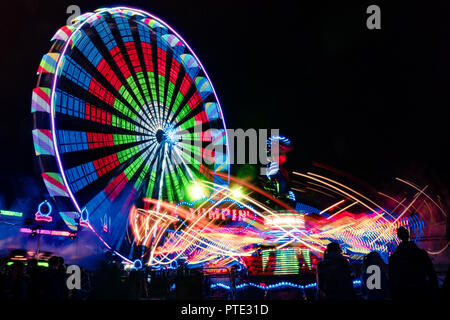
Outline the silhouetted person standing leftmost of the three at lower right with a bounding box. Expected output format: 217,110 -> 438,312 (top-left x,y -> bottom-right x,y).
317,242 -> 355,300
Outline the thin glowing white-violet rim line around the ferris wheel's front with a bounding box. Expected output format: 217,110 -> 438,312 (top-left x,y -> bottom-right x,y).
50,6 -> 230,213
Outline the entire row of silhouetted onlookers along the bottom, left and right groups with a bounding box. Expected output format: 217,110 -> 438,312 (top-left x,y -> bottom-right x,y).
0,227 -> 449,301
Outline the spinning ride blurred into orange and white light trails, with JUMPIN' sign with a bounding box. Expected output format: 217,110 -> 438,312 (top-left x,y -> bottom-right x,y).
133,177 -> 432,275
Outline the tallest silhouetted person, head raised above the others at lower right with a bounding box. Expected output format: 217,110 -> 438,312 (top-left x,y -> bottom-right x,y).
389,227 -> 438,299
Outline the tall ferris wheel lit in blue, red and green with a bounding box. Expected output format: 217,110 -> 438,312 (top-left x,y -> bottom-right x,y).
32,7 -> 229,256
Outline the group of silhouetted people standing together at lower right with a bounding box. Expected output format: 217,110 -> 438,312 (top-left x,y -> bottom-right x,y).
317,227 -> 448,300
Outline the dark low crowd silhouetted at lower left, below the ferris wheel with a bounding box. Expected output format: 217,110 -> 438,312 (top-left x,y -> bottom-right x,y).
0,254 -> 199,301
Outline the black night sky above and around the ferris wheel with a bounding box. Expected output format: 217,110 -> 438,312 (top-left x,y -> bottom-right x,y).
0,0 -> 450,209
